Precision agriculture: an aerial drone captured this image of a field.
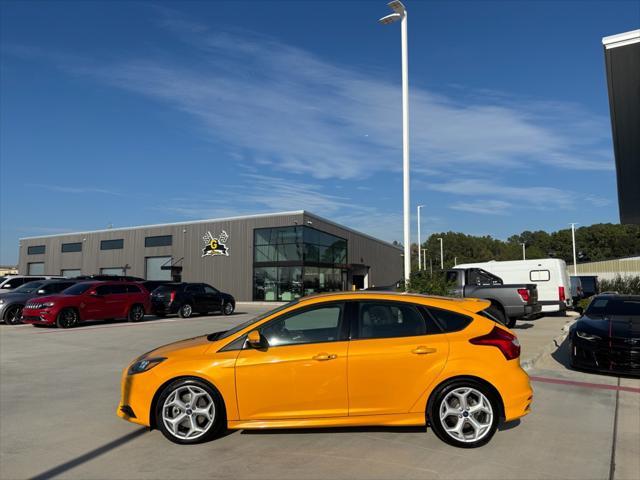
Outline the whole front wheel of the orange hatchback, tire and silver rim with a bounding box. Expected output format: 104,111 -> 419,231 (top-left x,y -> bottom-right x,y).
156,379 -> 226,444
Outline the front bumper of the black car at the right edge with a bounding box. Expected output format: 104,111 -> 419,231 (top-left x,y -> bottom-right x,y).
569,334 -> 640,376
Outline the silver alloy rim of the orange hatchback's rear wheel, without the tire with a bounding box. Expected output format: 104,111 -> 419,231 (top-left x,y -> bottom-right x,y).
439,387 -> 493,443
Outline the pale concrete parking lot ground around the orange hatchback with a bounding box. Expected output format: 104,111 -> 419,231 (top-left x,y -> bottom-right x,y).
0,305 -> 640,479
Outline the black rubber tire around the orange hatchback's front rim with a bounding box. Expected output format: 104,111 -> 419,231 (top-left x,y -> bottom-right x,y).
154,378 -> 227,445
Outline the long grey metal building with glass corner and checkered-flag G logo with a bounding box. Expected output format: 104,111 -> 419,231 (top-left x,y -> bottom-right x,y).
18,210 -> 403,301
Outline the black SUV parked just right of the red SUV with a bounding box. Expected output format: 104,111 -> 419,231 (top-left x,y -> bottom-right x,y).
151,283 -> 236,318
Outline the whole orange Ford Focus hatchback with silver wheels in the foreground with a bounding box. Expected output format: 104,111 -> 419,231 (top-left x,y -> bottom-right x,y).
118,292 -> 532,448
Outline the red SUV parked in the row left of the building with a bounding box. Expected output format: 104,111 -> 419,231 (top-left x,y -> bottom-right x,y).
22,282 -> 151,328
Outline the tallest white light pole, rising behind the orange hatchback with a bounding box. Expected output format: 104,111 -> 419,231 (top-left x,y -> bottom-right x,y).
378,0 -> 411,282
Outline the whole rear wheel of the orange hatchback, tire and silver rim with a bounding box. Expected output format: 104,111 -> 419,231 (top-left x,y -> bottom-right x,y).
427,379 -> 500,448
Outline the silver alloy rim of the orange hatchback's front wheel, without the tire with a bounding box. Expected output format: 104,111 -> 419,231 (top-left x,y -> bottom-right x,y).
162,385 -> 216,440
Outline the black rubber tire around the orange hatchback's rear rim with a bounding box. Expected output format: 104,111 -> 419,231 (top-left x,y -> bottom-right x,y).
427,379 -> 502,448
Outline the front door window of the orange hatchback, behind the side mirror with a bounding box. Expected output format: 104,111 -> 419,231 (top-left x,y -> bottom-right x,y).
260,304 -> 343,347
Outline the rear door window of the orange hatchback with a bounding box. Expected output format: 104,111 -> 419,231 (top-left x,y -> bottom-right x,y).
356,302 -> 427,339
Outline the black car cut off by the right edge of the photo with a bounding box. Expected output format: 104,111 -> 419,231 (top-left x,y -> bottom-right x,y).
569,294 -> 640,375
